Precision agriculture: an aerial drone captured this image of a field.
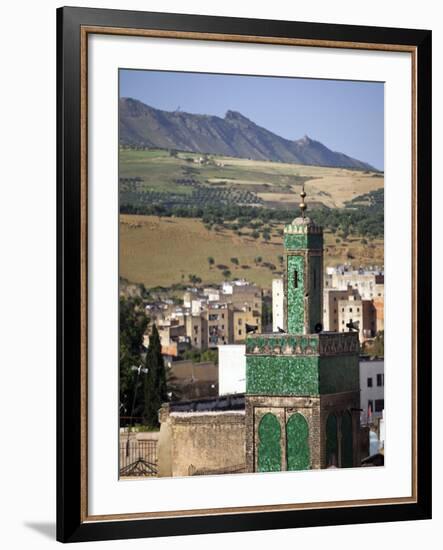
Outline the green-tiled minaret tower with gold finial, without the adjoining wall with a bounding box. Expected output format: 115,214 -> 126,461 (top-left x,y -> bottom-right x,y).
245,186 -> 360,472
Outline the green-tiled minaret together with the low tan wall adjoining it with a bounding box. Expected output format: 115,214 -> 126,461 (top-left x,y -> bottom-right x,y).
159,190 -> 368,476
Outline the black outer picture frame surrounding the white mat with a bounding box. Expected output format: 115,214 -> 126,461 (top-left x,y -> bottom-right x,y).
57,7 -> 432,542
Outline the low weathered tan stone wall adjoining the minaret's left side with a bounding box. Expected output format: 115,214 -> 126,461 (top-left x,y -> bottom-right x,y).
158,406 -> 245,477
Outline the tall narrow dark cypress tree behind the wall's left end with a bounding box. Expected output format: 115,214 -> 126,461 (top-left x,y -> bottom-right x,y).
144,324 -> 168,428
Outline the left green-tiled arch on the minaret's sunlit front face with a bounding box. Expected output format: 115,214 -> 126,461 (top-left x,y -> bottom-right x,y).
257,413 -> 281,472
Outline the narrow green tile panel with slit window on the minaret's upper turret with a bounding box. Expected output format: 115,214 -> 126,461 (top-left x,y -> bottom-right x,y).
287,256 -> 305,334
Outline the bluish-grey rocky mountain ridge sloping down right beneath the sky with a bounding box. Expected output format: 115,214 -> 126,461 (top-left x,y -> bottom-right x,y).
119,98 -> 378,172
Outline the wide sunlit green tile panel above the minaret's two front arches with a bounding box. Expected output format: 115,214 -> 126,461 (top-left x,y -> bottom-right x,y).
246,355 -> 319,395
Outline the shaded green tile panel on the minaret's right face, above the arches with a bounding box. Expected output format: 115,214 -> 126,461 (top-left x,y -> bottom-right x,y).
319,354 -> 360,394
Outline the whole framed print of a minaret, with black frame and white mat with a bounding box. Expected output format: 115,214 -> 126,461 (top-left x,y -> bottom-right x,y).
57,8 -> 431,542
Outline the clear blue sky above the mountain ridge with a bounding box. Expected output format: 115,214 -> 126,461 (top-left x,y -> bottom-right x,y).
120,69 -> 384,170
